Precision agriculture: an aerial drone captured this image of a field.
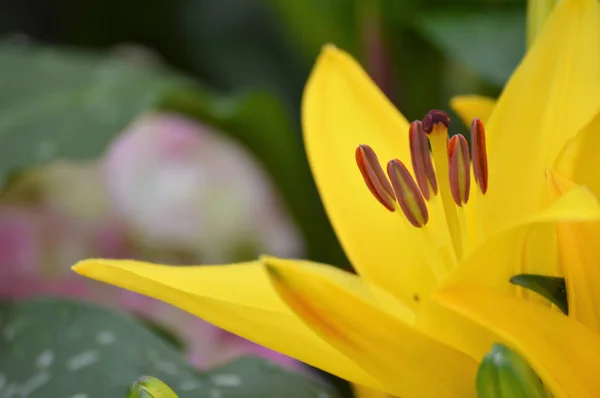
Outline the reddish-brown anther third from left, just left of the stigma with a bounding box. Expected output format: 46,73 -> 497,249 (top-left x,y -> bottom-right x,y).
408,120 -> 438,200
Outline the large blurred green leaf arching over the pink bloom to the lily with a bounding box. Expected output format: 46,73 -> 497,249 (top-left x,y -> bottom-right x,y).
0,43 -> 344,265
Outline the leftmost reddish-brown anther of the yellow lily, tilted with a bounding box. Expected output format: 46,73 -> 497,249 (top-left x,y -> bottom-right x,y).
355,145 -> 396,212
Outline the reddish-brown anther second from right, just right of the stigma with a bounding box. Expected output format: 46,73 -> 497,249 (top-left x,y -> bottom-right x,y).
448,134 -> 471,207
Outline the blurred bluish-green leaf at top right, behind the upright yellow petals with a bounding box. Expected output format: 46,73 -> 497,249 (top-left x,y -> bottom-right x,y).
415,7 -> 525,86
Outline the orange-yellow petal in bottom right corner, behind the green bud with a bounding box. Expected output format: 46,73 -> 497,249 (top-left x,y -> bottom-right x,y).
436,288 -> 600,398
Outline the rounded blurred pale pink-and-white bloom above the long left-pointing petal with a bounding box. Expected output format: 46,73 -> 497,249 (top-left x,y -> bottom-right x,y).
105,110 -> 302,263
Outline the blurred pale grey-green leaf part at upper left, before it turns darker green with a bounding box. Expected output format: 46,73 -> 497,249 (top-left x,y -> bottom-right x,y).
0,43 -> 186,185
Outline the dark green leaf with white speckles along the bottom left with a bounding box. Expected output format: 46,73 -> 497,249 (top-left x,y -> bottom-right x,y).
0,299 -> 332,398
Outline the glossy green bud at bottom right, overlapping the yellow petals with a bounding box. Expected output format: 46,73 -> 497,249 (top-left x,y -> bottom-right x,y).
477,344 -> 550,398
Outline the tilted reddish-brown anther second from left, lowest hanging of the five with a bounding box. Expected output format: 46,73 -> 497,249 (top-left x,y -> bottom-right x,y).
387,159 -> 429,228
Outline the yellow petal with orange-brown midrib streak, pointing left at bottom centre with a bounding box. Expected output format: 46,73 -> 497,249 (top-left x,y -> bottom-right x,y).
266,258 -> 476,398
